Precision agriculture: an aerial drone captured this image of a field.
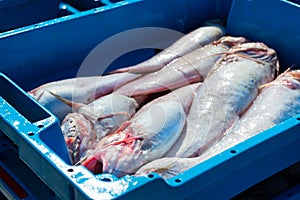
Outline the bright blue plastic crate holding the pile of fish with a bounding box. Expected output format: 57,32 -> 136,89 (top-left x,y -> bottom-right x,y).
0,0 -> 300,199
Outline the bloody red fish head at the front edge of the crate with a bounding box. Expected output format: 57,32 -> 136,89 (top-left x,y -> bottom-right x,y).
82,128 -> 151,177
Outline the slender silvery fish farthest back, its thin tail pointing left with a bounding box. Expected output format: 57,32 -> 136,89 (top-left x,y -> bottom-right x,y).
112,26 -> 225,74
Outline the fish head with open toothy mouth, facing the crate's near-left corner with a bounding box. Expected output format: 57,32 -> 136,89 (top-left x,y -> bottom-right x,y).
61,113 -> 95,163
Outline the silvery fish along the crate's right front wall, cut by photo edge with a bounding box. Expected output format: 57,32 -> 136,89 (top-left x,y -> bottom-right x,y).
196,70 -> 300,163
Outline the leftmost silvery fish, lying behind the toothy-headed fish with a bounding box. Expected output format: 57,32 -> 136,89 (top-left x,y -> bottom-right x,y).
28,73 -> 140,121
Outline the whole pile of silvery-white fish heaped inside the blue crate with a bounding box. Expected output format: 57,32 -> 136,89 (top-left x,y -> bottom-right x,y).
29,25 -> 300,183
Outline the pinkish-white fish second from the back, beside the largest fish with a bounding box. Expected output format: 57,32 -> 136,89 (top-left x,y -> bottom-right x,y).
114,36 -> 246,96
